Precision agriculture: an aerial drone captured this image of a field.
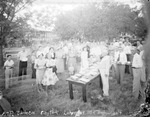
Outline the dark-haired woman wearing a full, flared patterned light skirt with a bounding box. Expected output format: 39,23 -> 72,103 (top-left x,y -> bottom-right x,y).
42,54 -> 59,92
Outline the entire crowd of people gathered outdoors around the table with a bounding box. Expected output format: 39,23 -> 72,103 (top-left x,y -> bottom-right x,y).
4,37 -> 146,98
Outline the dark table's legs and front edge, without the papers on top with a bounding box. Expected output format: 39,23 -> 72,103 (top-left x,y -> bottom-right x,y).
67,74 -> 102,102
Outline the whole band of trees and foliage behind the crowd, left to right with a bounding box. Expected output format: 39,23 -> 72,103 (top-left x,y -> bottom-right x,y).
0,0 -> 147,66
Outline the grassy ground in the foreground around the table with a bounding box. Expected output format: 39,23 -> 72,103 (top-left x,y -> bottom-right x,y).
0,63 -> 143,117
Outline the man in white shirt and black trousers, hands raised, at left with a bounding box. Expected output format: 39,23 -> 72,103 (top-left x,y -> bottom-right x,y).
18,47 -> 28,76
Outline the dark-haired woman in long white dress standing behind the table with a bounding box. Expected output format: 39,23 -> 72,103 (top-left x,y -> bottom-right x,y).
80,47 -> 89,72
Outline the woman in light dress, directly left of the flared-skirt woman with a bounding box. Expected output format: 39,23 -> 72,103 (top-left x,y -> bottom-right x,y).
34,53 -> 46,91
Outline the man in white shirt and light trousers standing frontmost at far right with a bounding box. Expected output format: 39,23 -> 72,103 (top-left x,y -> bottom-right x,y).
132,49 -> 144,99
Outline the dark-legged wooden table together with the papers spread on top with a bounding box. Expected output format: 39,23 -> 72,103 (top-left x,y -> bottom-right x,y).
67,63 -> 102,102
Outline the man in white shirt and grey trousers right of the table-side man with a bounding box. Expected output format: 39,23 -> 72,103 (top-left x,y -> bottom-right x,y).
116,48 -> 127,84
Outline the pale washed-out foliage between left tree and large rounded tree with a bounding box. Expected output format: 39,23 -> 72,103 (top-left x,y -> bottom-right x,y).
28,5 -> 60,31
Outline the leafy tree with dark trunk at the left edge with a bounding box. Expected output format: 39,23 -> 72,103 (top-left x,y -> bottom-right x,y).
0,0 -> 33,66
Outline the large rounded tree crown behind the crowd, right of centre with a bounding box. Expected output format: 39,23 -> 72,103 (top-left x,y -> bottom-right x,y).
55,1 -> 147,40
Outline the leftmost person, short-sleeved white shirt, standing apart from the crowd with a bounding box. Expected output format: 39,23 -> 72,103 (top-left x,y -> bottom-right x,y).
4,55 -> 14,89
